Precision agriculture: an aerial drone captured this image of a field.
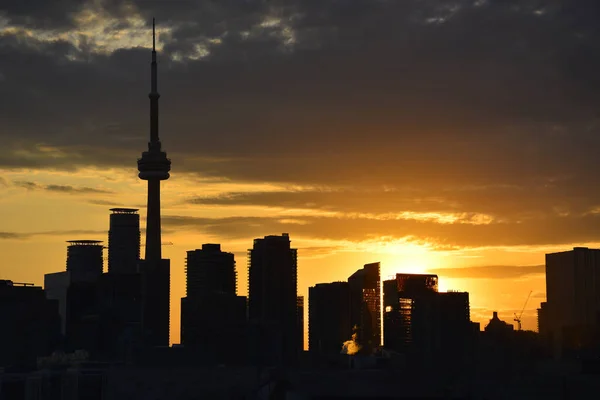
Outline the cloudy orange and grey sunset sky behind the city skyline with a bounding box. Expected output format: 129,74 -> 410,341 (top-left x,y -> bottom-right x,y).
0,0 -> 600,343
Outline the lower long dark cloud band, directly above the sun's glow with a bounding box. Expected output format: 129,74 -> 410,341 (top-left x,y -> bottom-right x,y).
162,216 -> 600,251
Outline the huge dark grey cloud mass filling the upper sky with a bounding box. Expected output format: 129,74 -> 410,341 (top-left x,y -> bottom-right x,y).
0,0 -> 600,246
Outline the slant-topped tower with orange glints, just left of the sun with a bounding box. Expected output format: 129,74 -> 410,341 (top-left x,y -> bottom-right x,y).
348,262 -> 381,351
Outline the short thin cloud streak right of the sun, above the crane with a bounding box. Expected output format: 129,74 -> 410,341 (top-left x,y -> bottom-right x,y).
429,265 -> 545,278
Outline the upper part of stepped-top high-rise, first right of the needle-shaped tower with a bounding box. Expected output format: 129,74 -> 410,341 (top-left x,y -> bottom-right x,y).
185,244 -> 237,297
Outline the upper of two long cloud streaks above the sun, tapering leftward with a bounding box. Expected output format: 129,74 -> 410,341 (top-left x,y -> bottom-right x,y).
187,183 -> 600,222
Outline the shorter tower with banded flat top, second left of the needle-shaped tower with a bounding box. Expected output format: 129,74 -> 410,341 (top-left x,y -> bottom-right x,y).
67,240 -> 104,282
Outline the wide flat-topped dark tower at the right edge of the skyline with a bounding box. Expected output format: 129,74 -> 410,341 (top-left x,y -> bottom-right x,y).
546,247 -> 600,358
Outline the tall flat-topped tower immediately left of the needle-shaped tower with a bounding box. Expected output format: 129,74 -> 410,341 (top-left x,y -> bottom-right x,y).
108,208 -> 140,274
